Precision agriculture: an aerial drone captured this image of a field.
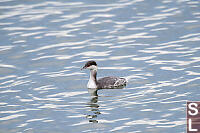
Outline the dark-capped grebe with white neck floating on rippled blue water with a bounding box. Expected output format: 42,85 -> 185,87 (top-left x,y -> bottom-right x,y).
81,61 -> 127,89
